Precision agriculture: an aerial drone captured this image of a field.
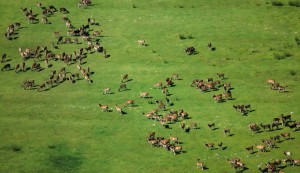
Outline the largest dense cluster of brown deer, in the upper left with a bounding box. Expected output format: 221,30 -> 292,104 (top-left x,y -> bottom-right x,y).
1,0 -> 102,91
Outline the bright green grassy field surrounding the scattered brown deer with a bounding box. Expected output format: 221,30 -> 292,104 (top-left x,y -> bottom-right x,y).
0,0 -> 300,173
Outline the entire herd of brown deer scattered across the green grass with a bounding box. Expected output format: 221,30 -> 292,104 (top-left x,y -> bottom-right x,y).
1,0 -> 300,173
